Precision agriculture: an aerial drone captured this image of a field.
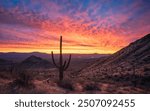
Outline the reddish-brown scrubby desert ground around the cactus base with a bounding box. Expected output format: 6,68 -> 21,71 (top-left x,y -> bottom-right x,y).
0,57 -> 150,94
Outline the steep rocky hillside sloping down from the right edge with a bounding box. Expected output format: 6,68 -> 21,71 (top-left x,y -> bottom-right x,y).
79,34 -> 150,77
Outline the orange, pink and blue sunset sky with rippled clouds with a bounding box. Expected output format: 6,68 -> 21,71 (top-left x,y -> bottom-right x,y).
0,0 -> 150,54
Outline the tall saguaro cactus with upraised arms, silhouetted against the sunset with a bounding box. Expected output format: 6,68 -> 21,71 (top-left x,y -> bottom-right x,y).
51,36 -> 71,81
